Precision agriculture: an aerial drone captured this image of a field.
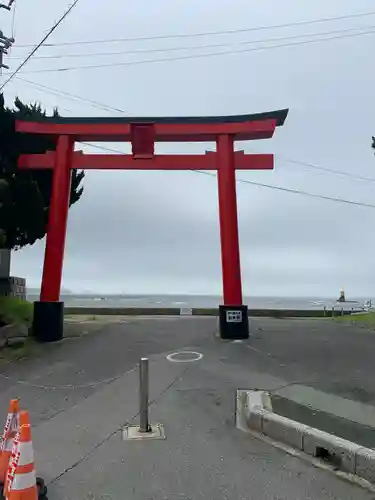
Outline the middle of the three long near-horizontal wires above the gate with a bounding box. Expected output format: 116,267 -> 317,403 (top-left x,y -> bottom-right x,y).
9,25 -> 375,60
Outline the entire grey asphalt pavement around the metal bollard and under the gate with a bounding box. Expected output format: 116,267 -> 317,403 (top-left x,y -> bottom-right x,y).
0,318 -> 375,500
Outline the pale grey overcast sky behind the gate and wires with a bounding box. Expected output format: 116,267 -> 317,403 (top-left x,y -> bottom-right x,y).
0,0 -> 375,297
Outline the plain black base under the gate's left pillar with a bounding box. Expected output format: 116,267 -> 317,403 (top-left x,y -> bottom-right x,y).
32,302 -> 64,342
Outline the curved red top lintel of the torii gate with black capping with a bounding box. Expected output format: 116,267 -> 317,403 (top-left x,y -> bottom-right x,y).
16,109 -> 288,142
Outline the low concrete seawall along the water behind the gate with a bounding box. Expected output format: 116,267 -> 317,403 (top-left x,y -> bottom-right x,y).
65,307 -> 351,318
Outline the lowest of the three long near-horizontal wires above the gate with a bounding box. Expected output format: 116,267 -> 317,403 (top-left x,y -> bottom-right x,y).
5,30 -> 375,75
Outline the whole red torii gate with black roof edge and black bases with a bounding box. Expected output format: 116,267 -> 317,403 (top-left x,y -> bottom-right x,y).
16,109 -> 288,341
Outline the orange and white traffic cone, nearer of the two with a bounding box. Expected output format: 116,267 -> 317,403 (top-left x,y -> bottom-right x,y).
5,422 -> 38,500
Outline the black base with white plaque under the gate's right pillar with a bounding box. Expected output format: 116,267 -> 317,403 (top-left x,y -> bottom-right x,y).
219,306 -> 249,340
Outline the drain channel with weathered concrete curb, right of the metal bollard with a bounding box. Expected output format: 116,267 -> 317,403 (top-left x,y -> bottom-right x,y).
236,390 -> 375,490
